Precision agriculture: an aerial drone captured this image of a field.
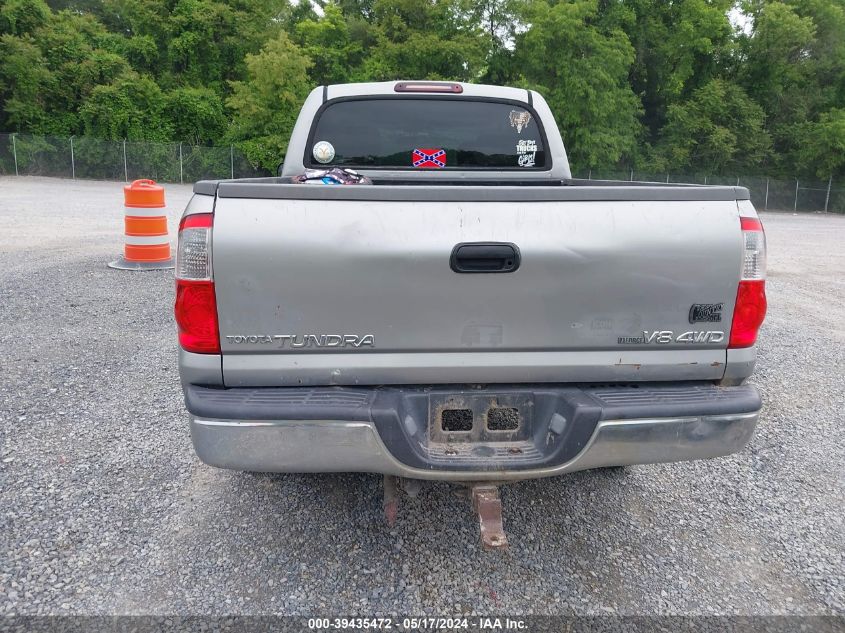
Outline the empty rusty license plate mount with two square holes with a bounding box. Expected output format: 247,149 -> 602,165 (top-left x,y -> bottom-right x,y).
428,393 -> 534,444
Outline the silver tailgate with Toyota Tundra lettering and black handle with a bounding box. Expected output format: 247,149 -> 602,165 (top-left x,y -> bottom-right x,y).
213,197 -> 742,386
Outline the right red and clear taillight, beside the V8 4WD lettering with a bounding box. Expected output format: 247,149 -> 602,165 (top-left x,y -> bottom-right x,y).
728,217 -> 766,348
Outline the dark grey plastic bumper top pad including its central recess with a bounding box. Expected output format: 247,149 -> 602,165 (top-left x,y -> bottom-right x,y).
185,383 -> 761,479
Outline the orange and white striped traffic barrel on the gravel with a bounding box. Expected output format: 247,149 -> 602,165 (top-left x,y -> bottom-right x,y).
109,180 -> 173,270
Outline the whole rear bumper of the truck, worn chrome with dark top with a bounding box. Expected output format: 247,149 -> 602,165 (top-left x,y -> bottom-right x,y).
185,384 -> 760,481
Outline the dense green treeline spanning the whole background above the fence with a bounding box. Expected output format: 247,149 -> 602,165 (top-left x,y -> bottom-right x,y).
0,0 -> 845,185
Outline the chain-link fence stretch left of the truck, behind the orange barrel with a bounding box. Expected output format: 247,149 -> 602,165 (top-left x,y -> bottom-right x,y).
0,134 -> 270,183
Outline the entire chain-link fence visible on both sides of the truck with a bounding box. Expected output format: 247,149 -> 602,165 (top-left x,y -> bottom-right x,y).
0,134 -> 845,213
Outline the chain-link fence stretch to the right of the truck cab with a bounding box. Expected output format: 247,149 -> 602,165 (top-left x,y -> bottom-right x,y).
574,169 -> 845,213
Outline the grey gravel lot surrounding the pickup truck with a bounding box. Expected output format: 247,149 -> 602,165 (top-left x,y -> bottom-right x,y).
0,177 -> 845,615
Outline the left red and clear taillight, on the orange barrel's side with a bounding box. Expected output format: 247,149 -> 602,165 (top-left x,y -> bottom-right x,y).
174,213 -> 220,354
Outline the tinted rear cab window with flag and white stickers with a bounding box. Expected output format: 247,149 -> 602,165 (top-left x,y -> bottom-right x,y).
304,97 -> 549,171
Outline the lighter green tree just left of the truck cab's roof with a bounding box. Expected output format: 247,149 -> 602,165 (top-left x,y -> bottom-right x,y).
226,33 -> 311,170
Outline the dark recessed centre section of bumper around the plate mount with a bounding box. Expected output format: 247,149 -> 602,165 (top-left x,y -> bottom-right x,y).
370,385 -> 601,466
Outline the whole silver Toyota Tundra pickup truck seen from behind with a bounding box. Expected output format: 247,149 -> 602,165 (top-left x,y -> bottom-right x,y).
176,82 -> 766,544
